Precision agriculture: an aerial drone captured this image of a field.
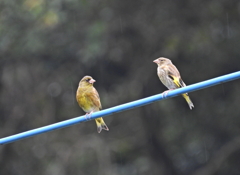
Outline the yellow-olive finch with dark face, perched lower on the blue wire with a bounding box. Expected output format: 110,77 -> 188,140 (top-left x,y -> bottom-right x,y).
76,76 -> 109,133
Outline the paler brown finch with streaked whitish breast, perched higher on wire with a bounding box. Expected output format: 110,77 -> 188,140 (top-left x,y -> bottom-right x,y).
153,57 -> 194,109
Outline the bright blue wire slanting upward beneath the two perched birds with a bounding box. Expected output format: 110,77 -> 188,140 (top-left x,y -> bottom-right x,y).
0,71 -> 240,144
